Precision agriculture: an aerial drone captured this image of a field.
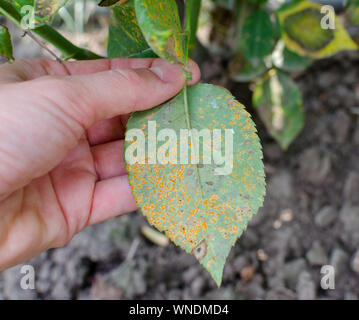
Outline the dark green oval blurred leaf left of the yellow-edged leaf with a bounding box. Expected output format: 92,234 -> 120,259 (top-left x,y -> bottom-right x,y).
240,9 -> 276,66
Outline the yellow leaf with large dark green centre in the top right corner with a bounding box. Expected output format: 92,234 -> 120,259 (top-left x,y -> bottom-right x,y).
277,0 -> 358,59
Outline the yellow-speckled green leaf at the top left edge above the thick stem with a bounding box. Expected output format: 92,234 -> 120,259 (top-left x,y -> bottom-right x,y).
8,0 -> 68,27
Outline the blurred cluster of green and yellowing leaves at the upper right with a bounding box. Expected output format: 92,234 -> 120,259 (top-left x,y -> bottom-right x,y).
208,0 -> 359,149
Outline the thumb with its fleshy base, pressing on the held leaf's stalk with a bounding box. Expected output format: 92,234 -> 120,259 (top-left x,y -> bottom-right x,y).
0,59 -> 200,196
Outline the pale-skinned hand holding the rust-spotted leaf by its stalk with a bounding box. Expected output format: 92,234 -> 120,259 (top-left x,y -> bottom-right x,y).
0,59 -> 200,271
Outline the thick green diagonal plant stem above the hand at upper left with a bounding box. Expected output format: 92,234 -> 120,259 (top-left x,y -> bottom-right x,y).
0,0 -> 103,60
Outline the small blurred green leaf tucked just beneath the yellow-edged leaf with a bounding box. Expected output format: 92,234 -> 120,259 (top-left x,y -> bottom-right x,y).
272,41 -> 313,72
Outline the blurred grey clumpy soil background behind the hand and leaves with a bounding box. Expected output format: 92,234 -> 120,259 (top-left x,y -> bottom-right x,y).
0,0 -> 359,299
